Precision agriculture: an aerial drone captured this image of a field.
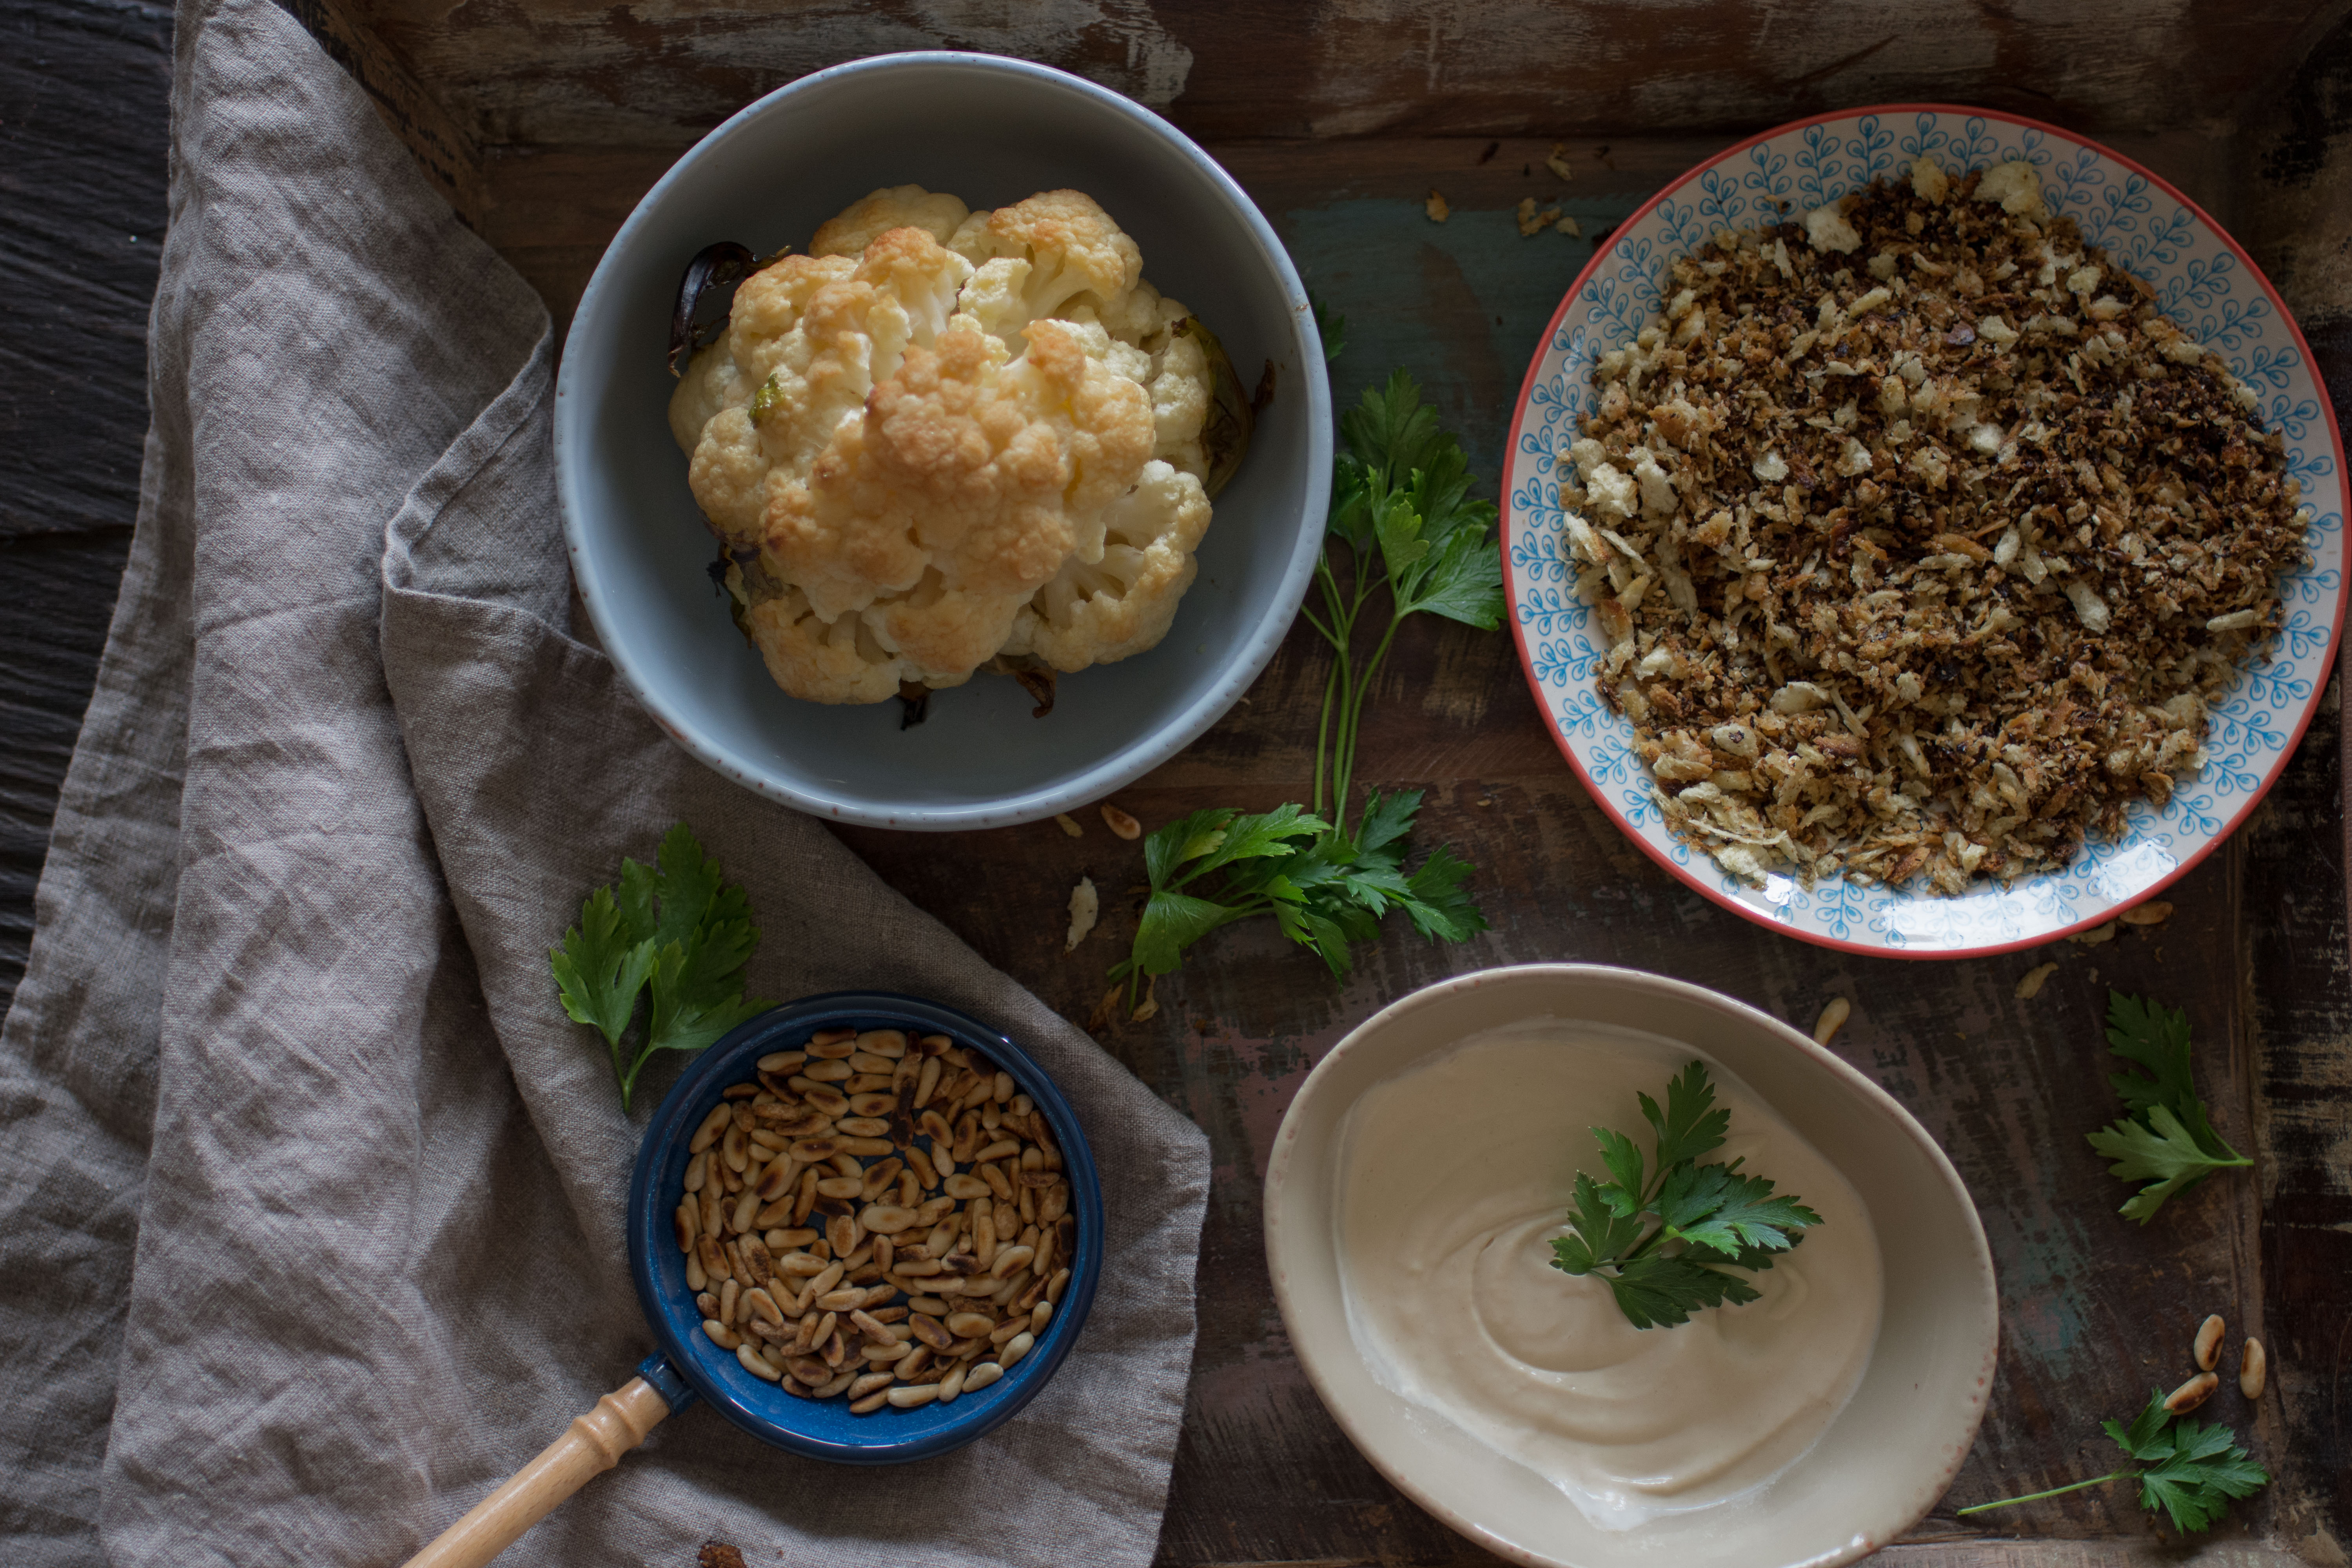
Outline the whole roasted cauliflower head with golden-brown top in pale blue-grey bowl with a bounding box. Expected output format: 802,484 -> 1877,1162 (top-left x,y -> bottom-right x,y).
670,186 -> 1230,703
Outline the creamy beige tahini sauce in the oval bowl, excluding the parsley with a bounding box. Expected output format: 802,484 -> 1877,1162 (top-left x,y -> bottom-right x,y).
1338,1020 -> 1882,1528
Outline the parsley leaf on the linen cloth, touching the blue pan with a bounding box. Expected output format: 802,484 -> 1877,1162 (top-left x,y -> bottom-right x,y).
548,823 -> 776,1110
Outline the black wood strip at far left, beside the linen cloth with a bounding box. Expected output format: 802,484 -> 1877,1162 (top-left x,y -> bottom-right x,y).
0,0 -> 172,1009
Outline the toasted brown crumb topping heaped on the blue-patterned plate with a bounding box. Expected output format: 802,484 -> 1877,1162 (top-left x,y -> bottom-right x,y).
1562,158 -> 2310,893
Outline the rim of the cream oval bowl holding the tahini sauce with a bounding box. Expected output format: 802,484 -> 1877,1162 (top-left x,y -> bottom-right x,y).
1263,964 -> 2002,1568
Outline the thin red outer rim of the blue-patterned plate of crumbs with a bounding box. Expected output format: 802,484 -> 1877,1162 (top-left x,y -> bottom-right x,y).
1496,101 -> 2352,959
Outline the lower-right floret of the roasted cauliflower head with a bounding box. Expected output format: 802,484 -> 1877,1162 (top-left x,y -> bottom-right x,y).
1004,458 -> 1209,672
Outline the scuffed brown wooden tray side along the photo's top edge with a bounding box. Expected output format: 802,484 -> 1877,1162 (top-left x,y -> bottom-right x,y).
343,0 -> 2343,148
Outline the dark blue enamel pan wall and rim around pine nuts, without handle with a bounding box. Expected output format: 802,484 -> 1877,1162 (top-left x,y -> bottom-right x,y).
626,992 -> 1103,1465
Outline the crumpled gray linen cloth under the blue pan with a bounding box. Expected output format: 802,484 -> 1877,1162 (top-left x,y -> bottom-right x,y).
0,0 -> 1209,1568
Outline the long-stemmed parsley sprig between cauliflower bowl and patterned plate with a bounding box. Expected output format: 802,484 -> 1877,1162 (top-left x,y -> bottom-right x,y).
1110,350 -> 1503,1006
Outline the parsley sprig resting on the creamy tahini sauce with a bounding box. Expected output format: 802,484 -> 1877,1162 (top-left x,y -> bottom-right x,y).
1552,1063 -> 1820,1328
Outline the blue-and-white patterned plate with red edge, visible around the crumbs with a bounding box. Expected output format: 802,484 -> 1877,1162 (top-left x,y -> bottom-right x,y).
1503,103 -> 2345,959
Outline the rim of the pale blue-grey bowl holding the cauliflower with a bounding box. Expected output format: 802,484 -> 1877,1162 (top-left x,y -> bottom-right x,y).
553,49 -> 1331,832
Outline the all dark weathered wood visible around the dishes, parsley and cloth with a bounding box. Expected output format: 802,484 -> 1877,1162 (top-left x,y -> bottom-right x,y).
0,0 -> 2352,1568
